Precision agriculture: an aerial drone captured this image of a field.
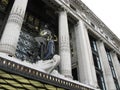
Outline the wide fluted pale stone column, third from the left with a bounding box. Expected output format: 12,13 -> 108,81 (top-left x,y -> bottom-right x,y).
75,20 -> 98,87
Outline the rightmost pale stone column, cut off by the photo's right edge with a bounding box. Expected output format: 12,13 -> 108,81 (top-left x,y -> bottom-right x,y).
111,52 -> 120,85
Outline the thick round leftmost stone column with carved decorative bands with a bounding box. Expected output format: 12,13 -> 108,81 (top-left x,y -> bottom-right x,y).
0,0 -> 28,55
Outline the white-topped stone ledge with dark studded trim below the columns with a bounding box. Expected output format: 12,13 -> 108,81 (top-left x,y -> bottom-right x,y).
0,53 -> 95,90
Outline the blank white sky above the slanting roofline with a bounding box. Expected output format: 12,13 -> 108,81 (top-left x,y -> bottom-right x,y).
81,0 -> 120,39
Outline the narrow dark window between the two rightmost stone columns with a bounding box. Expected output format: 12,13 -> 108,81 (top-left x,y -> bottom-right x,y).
106,48 -> 120,90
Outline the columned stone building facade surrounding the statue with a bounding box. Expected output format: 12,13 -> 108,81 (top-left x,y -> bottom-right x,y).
0,0 -> 120,90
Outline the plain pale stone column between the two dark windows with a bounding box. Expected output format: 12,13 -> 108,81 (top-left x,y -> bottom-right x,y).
97,41 -> 116,90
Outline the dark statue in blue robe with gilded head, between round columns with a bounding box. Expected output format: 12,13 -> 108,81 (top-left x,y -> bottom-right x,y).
35,25 -> 56,60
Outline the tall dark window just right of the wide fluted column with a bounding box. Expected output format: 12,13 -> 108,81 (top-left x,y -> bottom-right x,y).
89,36 -> 106,90
